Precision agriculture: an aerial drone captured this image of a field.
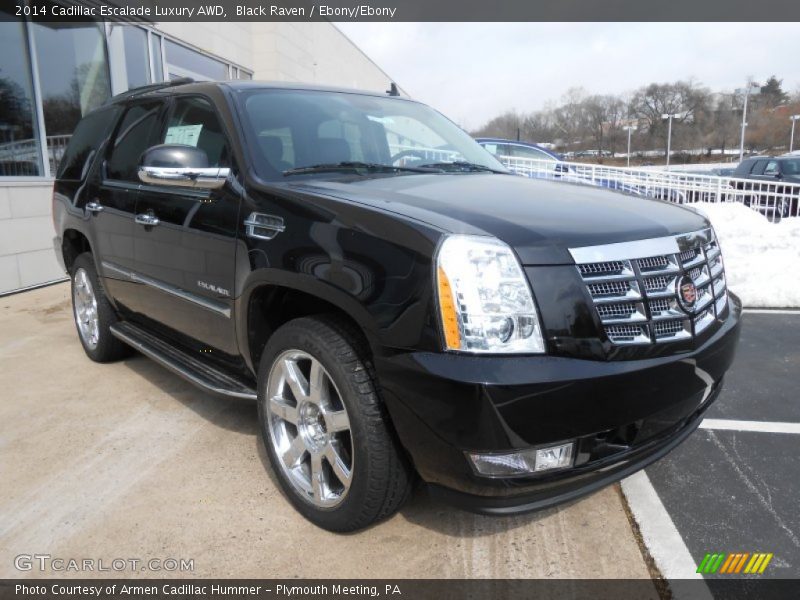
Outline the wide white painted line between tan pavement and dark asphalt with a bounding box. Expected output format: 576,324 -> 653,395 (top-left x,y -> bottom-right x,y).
622,470 -> 711,598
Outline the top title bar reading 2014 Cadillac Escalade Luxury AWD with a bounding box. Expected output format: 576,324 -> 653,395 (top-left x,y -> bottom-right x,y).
0,0 -> 800,21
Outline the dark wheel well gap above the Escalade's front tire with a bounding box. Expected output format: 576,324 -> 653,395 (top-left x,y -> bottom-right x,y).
247,285 -> 371,369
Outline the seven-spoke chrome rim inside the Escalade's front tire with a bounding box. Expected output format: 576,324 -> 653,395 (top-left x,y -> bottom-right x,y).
265,350 -> 353,508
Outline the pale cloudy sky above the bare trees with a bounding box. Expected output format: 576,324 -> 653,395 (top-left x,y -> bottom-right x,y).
336,22 -> 800,130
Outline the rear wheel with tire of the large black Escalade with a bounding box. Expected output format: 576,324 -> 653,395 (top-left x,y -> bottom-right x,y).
70,252 -> 131,363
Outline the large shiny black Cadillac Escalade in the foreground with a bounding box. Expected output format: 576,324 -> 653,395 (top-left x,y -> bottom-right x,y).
53,82 -> 741,531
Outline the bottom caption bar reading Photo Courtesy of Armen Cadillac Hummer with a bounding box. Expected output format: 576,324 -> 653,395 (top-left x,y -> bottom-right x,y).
0,577 -> 797,600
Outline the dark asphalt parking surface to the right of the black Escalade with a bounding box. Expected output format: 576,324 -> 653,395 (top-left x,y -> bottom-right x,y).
646,313 -> 800,578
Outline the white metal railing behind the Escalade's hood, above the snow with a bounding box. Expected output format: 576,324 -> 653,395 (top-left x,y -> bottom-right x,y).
497,156 -> 800,220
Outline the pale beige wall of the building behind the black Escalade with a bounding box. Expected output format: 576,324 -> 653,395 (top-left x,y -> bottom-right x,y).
0,23 -> 398,294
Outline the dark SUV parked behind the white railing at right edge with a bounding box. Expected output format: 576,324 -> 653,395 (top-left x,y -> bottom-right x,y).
731,156 -> 800,220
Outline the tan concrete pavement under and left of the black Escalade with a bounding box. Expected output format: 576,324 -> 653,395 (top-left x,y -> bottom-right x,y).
0,284 -> 657,580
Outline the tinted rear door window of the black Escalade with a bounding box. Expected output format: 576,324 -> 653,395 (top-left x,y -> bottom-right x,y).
106,102 -> 162,183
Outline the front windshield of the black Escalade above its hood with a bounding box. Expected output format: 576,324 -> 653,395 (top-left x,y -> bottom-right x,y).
234,89 -> 507,180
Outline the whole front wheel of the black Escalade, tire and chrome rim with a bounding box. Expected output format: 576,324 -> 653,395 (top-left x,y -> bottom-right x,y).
258,317 -> 412,532
